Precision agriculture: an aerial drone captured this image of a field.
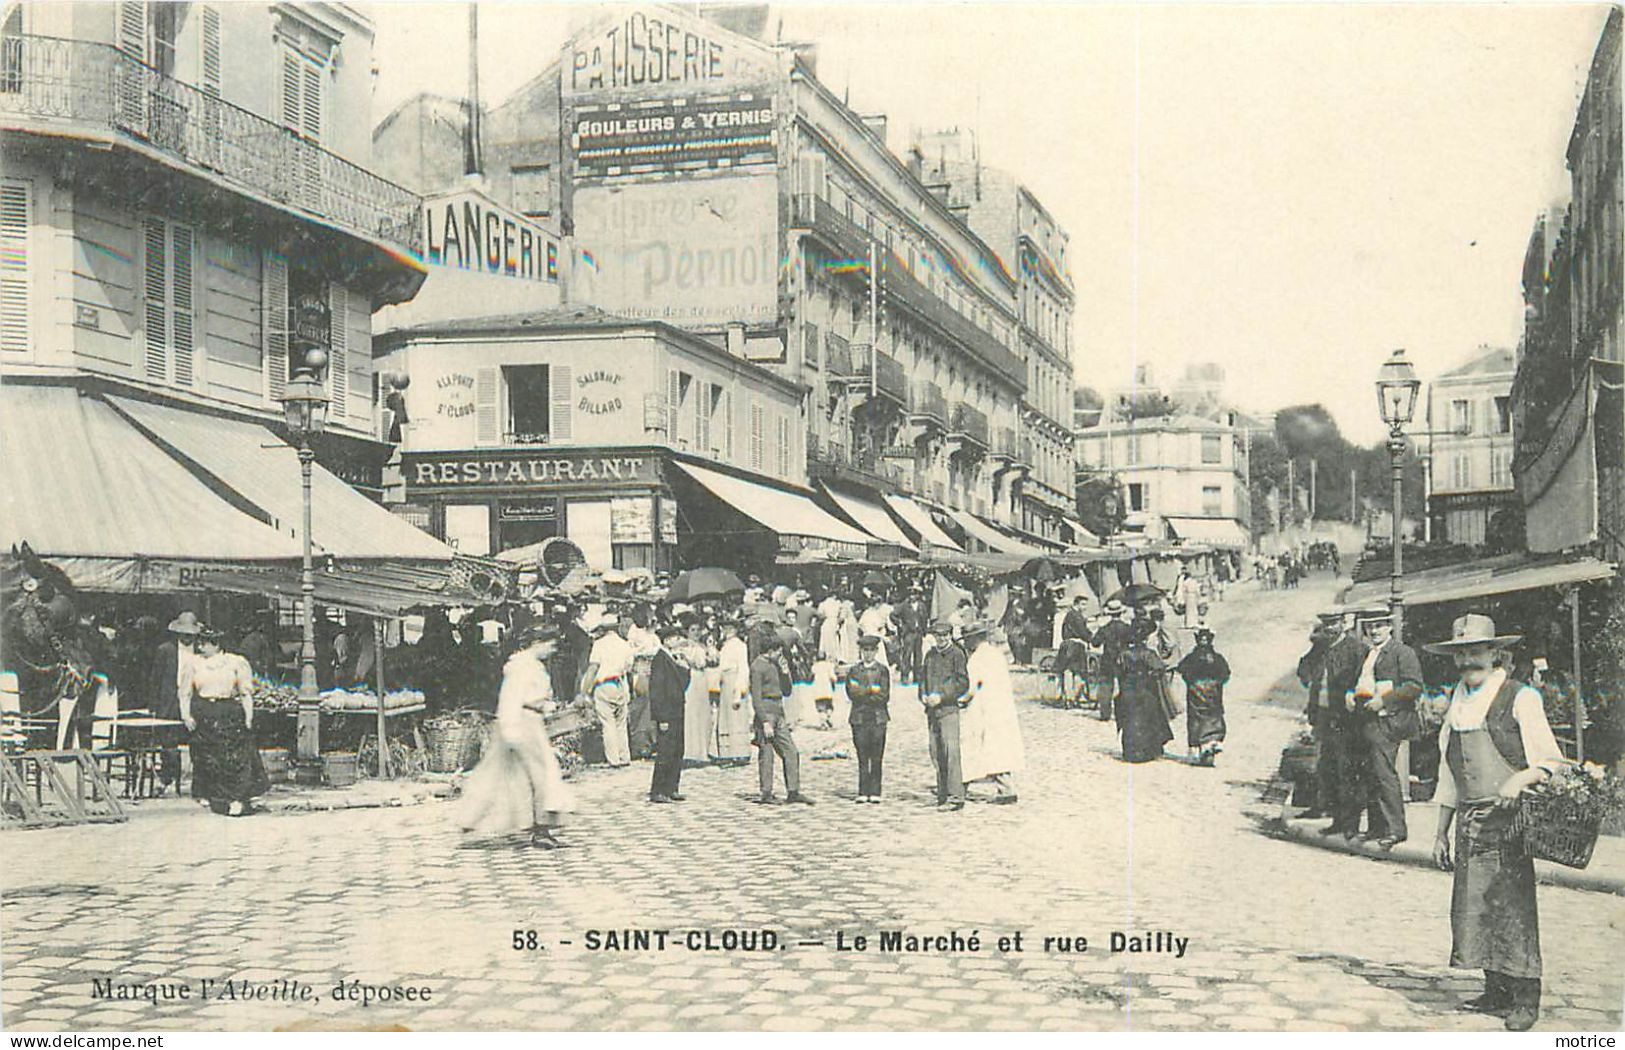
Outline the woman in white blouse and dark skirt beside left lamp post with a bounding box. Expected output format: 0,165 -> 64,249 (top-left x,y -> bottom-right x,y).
180,627 -> 271,816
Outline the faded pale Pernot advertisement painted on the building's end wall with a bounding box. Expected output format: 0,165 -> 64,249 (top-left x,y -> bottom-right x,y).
572,176 -> 778,325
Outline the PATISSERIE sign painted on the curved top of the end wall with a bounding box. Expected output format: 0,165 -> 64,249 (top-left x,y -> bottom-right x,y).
564,11 -> 765,94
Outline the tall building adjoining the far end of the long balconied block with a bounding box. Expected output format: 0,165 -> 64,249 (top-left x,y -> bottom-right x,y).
908,128 -> 1084,541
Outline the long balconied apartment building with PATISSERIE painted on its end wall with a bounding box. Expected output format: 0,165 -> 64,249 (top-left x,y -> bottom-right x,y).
367,5 -> 1069,562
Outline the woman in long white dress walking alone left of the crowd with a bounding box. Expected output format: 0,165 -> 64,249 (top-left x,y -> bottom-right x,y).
457,624 -> 575,850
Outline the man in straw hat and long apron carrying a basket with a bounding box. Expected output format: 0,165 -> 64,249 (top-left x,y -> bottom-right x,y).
1427,614 -> 1563,1032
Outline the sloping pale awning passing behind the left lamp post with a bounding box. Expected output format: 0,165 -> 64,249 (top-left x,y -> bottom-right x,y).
107,397 -> 453,561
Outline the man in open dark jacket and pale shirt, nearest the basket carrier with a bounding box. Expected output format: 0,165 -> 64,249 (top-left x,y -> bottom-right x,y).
1344,613 -> 1422,850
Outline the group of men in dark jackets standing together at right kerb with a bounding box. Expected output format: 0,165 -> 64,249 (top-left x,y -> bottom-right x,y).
1298,613 -> 1422,850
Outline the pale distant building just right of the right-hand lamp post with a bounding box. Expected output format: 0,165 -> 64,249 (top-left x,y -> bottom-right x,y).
1424,346 -> 1518,546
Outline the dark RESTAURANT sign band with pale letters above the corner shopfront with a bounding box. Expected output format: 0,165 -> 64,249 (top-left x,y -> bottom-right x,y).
403,449 -> 658,492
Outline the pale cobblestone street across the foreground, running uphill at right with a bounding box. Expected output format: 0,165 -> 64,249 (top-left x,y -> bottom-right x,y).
0,575 -> 1625,1032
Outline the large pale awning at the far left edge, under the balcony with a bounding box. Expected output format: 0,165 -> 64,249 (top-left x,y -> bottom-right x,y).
0,384 -> 299,568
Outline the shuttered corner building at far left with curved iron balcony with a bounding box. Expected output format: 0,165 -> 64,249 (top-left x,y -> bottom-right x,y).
0,2 -> 444,585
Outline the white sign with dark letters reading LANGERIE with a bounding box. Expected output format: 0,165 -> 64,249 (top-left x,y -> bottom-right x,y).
423,190 -> 559,284
